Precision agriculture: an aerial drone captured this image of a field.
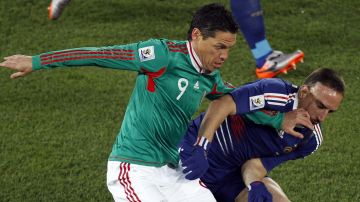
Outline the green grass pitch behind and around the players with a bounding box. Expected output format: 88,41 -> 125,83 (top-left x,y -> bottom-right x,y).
0,0 -> 360,202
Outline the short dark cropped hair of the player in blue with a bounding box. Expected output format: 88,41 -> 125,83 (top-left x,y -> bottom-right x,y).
304,68 -> 345,95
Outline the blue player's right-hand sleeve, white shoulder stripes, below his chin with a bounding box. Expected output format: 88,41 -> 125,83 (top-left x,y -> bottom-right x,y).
261,125 -> 323,172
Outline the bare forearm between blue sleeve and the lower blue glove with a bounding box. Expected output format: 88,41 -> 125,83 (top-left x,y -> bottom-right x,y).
241,158 -> 267,186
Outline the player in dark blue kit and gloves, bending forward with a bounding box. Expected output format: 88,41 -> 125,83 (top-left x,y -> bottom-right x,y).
179,68 -> 345,201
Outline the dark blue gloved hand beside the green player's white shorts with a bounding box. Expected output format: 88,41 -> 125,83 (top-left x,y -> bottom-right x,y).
182,137 -> 209,180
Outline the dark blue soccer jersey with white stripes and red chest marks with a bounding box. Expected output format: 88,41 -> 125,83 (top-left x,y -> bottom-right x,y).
180,79 -> 322,201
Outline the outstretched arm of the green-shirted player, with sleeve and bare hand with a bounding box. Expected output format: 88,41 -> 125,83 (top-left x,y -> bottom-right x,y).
0,40 -> 169,78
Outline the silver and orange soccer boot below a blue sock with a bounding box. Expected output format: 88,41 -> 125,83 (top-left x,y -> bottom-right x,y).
256,50 -> 304,79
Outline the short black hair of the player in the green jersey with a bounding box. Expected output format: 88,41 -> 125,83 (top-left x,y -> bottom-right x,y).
188,3 -> 238,41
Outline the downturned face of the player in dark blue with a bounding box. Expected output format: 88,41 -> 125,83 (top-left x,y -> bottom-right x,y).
299,82 -> 343,124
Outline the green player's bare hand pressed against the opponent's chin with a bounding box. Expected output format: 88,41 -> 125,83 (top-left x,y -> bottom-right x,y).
281,109 -> 314,138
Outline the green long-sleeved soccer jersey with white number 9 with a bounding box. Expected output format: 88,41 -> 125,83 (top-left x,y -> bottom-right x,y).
33,39 -> 233,167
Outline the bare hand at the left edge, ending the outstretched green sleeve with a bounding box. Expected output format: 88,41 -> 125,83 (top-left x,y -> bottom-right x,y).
0,55 -> 33,79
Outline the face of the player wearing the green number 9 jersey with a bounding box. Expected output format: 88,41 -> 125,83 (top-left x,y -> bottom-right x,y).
191,28 -> 236,72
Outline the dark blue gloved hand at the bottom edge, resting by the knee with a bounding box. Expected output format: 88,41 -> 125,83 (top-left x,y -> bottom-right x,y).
248,181 -> 272,202
